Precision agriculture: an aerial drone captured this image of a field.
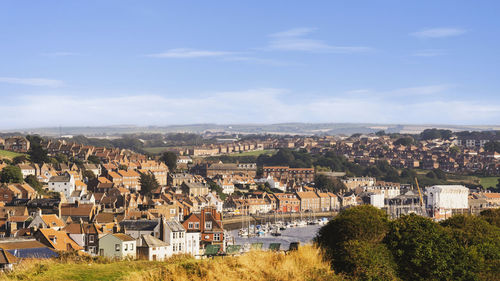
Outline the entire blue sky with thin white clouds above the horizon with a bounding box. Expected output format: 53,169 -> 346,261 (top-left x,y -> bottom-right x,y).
0,0 -> 500,129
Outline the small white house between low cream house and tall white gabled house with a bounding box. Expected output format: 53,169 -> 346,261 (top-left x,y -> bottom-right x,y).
137,234 -> 173,261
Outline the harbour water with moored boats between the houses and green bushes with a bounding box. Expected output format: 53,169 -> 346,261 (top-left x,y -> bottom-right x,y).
230,225 -> 321,249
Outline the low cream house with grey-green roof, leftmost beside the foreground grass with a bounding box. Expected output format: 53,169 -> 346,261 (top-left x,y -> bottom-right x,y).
99,233 -> 137,259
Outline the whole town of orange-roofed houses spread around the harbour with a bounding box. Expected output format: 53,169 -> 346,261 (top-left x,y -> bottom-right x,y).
0,129 -> 500,268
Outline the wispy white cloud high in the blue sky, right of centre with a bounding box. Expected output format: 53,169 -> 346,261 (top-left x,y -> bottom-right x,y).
267,28 -> 372,53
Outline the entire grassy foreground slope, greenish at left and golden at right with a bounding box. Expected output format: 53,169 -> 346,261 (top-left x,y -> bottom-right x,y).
0,245 -> 341,281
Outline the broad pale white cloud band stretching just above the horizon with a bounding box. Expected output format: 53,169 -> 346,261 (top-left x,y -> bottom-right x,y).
0,85 -> 500,127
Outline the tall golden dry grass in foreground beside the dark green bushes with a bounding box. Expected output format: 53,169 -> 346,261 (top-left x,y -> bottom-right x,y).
124,245 -> 341,281
